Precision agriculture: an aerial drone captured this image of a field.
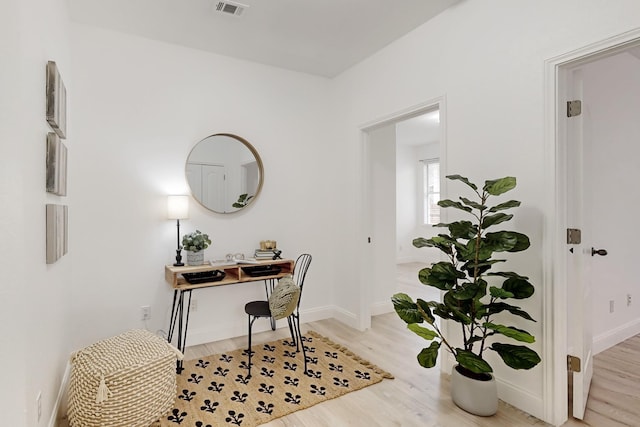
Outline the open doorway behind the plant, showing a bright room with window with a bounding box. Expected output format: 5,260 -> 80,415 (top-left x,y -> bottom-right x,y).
360,99 -> 445,329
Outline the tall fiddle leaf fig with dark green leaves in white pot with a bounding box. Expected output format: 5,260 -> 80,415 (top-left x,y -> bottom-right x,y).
392,175 -> 540,416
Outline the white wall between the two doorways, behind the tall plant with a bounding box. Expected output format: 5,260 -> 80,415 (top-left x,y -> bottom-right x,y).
334,0 -> 640,418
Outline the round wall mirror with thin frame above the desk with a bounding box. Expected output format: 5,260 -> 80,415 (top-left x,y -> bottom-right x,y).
186,133 -> 264,213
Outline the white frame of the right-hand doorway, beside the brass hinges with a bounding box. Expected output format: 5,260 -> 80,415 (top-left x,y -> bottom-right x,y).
542,29 -> 640,426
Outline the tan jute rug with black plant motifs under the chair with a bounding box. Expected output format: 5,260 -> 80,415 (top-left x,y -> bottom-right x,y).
153,331 -> 393,427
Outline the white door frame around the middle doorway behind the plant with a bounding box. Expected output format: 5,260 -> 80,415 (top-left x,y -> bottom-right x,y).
357,96 -> 452,358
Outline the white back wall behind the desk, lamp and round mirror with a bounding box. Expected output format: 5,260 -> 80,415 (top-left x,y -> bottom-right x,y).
69,25 -> 339,356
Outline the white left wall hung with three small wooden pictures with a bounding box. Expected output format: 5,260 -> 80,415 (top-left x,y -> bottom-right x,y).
0,0 -> 73,427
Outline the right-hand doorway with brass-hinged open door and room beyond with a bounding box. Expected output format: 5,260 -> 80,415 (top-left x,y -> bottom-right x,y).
545,30 -> 640,425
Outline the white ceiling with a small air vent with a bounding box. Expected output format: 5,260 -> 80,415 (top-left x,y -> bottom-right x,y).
69,0 -> 461,77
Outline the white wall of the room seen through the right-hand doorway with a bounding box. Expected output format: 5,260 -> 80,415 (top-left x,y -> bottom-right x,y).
582,53 -> 640,352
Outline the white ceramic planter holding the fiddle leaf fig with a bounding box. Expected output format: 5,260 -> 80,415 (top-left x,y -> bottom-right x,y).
451,366 -> 498,417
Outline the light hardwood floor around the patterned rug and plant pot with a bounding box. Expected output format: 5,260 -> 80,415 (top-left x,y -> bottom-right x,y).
61,264 -> 640,427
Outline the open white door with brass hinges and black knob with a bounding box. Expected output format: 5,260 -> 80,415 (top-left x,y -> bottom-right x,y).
559,69 -> 593,419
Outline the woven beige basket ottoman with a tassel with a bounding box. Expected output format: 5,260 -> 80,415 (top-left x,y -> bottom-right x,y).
67,329 -> 182,427
